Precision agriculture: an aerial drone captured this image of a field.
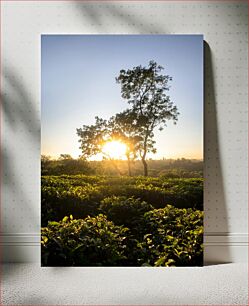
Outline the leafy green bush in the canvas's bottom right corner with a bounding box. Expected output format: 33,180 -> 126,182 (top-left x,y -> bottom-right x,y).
138,205 -> 203,266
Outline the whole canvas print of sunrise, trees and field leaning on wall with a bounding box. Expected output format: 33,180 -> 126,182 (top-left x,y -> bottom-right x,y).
41,35 -> 203,268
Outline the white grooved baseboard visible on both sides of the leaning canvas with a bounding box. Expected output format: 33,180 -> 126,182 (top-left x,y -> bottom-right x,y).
0,233 -> 248,264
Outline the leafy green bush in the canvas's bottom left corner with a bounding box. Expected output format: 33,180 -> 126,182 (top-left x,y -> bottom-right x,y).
41,214 -> 128,266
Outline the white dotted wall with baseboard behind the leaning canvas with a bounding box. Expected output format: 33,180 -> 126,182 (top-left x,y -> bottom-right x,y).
1,1 -> 248,262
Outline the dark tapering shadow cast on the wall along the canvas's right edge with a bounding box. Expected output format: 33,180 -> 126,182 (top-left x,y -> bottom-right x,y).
204,42 -> 231,264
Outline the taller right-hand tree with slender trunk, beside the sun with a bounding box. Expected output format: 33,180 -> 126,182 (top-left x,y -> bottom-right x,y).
116,61 -> 179,176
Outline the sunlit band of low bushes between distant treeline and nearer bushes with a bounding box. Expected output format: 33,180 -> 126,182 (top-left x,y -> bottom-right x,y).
41,175 -> 203,226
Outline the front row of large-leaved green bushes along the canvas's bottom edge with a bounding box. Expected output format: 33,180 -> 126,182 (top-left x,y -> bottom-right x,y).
41,205 -> 203,267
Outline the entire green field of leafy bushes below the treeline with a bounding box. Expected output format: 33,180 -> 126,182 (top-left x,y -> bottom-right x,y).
41,175 -> 203,266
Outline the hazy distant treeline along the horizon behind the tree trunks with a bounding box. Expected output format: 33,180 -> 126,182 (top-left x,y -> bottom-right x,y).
41,154 -> 203,178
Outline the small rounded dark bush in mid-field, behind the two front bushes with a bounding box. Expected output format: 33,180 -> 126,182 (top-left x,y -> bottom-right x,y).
100,196 -> 153,227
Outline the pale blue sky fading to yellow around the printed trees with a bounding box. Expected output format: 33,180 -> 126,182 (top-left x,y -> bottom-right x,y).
41,35 -> 204,159
